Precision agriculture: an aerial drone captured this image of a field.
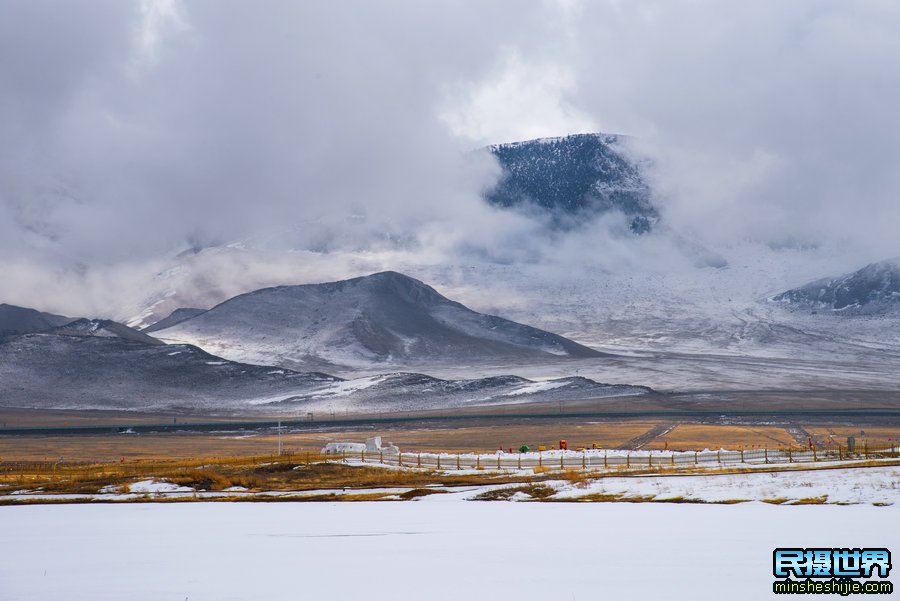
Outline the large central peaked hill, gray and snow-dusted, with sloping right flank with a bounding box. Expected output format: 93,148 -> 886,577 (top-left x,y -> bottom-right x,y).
156,271 -> 601,369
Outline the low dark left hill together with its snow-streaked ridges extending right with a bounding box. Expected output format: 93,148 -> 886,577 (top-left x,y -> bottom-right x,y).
0,334 -> 651,415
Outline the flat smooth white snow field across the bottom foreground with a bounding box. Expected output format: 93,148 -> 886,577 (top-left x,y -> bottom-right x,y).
0,502 -> 900,601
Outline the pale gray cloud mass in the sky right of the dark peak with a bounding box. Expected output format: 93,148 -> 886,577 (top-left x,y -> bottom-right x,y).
575,1 -> 900,253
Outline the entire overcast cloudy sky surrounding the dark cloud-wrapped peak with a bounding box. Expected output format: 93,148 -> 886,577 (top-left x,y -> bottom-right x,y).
0,0 -> 900,314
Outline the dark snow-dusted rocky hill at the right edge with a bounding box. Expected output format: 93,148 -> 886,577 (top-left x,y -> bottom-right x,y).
772,259 -> 900,315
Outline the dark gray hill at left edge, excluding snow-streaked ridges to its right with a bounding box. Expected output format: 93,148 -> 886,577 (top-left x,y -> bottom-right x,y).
0,334 -> 338,411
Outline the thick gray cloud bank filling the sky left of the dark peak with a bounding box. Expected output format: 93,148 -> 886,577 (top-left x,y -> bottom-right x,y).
0,2 -> 548,263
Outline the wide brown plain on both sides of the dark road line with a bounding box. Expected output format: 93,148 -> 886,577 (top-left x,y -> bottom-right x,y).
0,390 -> 900,461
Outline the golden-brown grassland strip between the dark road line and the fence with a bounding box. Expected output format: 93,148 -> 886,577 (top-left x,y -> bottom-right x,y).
0,420 -> 900,462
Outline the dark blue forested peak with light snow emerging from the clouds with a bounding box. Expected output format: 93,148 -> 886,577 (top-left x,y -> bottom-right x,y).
485,134 -> 659,233
